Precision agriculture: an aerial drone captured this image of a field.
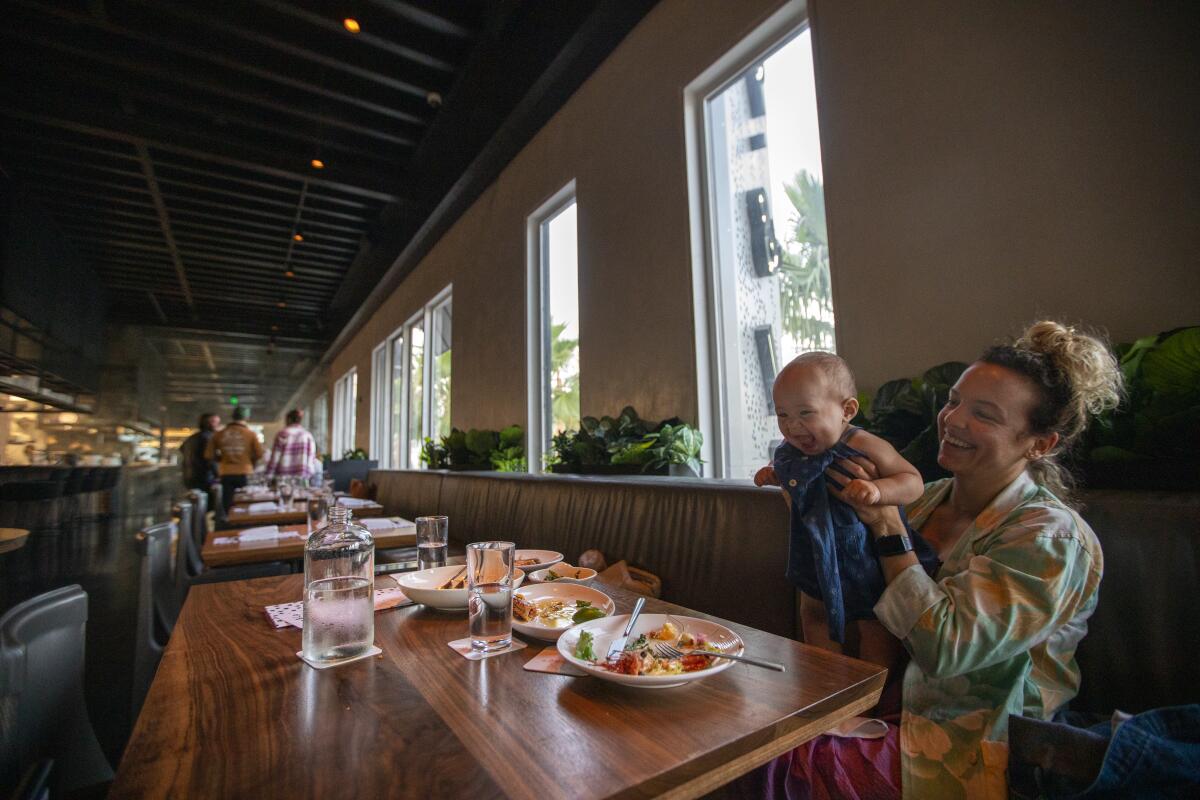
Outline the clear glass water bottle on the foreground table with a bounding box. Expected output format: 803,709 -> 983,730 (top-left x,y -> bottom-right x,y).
302,506 -> 374,661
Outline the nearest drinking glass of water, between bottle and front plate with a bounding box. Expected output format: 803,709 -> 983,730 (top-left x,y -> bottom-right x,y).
467,542 -> 516,652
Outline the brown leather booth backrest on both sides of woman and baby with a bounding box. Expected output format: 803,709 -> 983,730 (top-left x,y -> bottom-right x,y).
370,470 -> 1200,712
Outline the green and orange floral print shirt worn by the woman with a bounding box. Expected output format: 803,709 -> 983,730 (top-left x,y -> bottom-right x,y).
875,473 -> 1104,798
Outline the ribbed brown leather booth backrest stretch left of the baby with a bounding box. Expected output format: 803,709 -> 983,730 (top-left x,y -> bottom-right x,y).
371,470 -> 796,636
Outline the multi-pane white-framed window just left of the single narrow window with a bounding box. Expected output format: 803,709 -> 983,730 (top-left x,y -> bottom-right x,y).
371,287 -> 452,469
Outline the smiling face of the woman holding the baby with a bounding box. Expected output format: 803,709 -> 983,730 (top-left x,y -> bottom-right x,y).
937,361 -> 1057,477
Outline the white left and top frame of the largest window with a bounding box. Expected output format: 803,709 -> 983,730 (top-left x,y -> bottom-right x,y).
684,0 -> 809,477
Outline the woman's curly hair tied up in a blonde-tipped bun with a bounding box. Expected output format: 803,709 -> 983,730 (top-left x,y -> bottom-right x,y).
979,320 -> 1122,503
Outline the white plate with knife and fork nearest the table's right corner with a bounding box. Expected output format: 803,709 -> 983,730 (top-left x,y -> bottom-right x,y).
558,614 -> 745,688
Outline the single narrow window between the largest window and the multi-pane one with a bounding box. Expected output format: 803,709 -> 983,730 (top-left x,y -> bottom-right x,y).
527,181 -> 580,471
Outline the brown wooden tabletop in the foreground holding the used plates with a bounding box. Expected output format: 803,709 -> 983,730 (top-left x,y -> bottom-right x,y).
109,575 -> 886,800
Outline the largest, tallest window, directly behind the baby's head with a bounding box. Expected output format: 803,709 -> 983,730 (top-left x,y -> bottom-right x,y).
685,4 -> 835,477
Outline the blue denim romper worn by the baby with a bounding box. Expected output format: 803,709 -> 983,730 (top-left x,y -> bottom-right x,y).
772,426 -> 938,644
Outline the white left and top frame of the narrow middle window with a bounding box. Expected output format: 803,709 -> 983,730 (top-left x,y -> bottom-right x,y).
526,179 -> 582,475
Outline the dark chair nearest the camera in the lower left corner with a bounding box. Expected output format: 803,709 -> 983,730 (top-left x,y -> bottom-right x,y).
0,585 -> 113,796
